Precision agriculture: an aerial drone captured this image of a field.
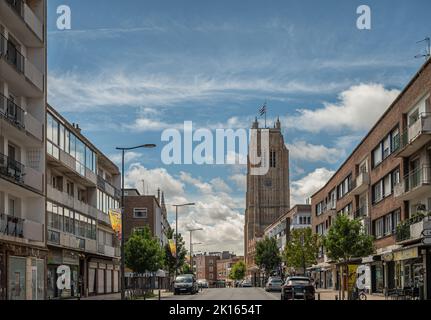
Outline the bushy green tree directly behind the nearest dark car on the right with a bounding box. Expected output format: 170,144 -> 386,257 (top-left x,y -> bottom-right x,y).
283,228 -> 321,273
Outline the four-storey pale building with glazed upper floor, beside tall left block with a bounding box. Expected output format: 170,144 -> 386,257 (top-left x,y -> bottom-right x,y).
46,106 -> 121,299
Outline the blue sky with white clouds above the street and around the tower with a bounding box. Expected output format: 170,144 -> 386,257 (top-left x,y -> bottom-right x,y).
48,0 -> 431,254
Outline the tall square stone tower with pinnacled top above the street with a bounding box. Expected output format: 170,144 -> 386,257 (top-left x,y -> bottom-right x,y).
244,120 -> 290,285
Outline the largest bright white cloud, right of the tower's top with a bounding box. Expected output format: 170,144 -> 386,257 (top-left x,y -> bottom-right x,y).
284,84 -> 400,133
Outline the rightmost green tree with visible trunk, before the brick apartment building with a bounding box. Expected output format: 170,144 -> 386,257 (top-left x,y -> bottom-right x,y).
323,215 -> 374,298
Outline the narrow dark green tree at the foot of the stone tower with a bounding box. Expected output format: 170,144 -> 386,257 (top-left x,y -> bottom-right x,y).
255,237 -> 281,277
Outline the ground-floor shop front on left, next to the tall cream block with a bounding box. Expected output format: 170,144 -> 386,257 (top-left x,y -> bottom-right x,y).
47,249 -> 85,299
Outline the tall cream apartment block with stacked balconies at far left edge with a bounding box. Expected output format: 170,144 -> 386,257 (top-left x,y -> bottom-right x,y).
0,0 -> 48,300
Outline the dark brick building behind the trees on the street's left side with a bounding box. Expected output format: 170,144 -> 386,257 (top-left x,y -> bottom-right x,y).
124,189 -> 170,247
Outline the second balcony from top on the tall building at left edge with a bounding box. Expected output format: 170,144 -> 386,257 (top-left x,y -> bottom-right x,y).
0,34 -> 45,98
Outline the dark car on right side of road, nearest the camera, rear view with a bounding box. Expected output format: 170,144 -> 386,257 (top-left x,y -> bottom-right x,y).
281,277 -> 316,300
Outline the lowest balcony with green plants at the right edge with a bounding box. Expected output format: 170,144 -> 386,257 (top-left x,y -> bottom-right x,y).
396,216 -> 431,243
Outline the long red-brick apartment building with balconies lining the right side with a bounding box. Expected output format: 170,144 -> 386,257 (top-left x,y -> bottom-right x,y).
312,60 -> 431,298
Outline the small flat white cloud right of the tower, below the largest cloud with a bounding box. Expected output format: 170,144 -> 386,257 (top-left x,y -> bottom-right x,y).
286,141 -> 345,164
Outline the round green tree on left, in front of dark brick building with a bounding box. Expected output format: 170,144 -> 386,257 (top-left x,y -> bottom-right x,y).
124,227 -> 164,273
